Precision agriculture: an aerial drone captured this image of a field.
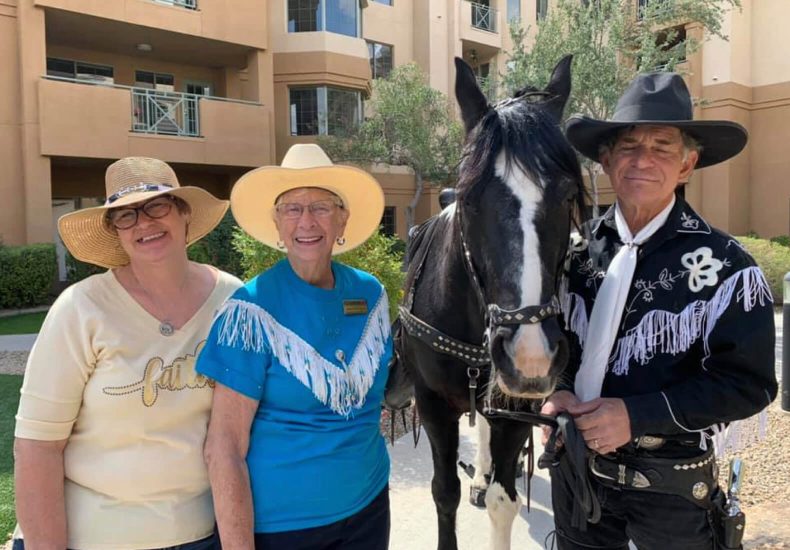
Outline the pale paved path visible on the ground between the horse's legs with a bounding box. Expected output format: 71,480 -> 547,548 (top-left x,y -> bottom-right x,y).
390,417 -> 554,550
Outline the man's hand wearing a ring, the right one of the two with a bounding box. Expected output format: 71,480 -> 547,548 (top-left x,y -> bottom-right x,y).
568,397 -> 631,454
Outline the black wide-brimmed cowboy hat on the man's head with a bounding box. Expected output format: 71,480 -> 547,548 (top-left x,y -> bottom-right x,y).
566,72 -> 748,168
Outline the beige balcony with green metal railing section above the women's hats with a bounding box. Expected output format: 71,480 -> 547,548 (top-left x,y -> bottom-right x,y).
39,76 -> 274,167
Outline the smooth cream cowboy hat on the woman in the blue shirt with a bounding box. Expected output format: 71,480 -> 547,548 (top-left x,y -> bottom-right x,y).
230,144 -> 384,254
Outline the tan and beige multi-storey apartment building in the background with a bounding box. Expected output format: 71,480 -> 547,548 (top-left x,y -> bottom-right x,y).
0,0 -> 790,276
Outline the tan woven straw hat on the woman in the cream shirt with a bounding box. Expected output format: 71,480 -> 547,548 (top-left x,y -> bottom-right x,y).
58,157 -> 228,268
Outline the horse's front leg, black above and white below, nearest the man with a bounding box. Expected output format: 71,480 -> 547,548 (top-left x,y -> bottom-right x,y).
486,419 -> 532,550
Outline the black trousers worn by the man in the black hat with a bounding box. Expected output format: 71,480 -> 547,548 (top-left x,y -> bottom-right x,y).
551,469 -> 714,550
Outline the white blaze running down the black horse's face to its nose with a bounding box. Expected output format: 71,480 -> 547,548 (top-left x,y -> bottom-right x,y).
496,153 -> 555,382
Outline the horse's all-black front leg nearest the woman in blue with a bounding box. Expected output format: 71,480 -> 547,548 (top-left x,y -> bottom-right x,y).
416,385 -> 461,550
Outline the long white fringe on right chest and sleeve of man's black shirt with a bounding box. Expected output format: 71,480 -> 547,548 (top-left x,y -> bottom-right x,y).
611,267 -> 771,375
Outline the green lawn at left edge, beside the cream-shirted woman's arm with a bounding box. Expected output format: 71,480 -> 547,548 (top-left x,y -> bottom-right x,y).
0,374 -> 22,545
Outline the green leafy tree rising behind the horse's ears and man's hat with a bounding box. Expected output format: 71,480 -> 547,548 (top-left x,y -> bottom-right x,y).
502,0 -> 741,214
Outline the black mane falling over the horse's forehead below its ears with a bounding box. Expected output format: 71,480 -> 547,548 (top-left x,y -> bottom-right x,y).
458,96 -> 586,221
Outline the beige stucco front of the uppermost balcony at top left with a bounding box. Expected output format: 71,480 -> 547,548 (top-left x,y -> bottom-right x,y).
34,0 -> 268,49
